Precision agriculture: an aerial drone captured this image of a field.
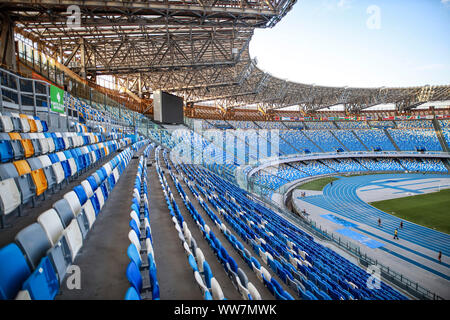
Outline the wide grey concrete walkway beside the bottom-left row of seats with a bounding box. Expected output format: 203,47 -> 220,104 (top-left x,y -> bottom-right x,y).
56,148 -> 143,300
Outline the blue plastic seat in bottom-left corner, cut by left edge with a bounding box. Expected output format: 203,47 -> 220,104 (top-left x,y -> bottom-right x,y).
0,243 -> 31,300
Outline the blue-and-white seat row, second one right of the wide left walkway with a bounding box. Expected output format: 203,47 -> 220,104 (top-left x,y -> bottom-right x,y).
155,147 -> 225,300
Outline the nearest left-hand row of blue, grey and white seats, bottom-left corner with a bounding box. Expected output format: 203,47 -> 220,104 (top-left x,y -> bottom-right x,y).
0,141 -> 142,300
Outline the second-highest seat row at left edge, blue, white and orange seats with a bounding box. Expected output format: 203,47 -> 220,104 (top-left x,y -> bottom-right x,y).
0,132 -> 123,163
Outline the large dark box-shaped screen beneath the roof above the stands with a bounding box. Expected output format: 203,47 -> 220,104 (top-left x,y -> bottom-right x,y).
153,90 -> 183,124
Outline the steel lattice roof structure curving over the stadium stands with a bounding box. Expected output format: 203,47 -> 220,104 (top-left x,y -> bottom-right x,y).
0,0 -> 450,112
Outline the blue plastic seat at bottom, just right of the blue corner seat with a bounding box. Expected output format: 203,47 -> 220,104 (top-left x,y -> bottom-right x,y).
23,257 -> 59,300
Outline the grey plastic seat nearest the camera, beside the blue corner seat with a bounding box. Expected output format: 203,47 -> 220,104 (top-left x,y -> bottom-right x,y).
15,222 -> 51,270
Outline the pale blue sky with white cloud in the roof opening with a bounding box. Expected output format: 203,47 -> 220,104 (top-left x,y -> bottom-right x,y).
250,0 -> 450,87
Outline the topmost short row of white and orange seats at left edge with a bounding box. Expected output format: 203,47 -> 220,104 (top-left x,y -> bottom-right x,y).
0,112 -> 48,133
